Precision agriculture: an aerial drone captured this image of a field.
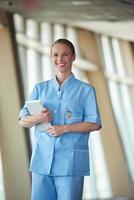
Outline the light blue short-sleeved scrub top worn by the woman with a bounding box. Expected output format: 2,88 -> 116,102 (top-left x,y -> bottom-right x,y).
19,74 -> 101,176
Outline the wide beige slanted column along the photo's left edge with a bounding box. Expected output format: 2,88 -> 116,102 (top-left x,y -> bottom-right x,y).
0,13 -> 30,200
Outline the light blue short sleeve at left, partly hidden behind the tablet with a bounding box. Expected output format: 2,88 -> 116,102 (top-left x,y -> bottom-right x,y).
19,84 -> 38,119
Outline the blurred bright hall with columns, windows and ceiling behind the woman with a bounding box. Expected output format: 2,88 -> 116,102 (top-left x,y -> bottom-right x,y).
0,0 -> 134,200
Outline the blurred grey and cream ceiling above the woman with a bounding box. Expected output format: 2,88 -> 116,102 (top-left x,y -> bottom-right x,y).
0,0 -> 134,41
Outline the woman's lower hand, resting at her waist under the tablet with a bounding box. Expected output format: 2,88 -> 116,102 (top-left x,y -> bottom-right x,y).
47,125 -> 65,137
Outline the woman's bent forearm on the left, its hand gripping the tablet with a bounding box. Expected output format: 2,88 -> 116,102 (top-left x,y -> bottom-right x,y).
19,115 -> 40,128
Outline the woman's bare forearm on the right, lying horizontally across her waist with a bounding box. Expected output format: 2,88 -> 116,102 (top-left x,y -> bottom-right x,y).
64,122 -> 101,133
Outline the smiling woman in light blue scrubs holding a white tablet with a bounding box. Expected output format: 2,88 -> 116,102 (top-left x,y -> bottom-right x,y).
19,39 -> 101,200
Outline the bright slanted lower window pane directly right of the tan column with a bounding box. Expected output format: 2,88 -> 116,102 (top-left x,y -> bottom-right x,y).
109,81 -> 134,180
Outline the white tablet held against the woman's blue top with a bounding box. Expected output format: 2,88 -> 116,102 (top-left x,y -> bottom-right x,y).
25,100 -> 51,131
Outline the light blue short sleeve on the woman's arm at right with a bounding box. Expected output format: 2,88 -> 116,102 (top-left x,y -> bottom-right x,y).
84,87 -> 101,125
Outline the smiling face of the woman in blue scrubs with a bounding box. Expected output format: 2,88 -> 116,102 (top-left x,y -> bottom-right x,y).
51,43 -> 75,73
